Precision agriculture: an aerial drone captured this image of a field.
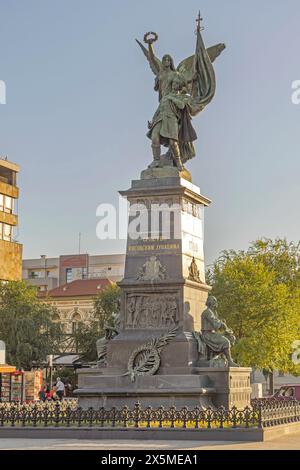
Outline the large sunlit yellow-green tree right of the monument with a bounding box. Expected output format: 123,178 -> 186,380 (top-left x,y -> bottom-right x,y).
208,239 -> 300,374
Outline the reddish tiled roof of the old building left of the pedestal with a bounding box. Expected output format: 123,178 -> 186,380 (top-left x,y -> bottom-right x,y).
47,279 -> 113,297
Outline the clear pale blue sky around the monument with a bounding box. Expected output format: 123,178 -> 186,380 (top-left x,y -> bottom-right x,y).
0,0 -> 300,263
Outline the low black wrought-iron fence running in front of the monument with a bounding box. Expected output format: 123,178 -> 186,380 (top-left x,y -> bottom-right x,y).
0,402 -> 300,429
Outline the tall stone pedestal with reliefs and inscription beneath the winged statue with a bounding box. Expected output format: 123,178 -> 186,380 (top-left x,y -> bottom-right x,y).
76,173 -> 251,408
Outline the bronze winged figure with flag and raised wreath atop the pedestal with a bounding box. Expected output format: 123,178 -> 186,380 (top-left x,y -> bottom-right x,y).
137,14 -> 225,171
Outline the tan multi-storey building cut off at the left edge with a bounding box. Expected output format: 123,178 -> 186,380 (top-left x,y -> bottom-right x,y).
0,159 -> 22,281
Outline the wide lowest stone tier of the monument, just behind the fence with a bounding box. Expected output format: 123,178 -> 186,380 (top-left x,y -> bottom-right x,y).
75,368 -> 251,409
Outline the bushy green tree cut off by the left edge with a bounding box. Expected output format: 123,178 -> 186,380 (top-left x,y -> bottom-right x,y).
0,281 -> 61,369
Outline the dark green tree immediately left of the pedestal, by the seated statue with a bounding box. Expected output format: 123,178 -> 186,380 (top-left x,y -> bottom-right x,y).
74,284 -> 120,362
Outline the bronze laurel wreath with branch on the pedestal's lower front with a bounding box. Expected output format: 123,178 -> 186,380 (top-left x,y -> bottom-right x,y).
124,327 -> 177,382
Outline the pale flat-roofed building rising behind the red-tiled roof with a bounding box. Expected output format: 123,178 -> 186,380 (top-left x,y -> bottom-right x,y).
23,254 -> 125,291
